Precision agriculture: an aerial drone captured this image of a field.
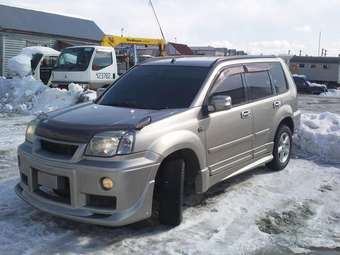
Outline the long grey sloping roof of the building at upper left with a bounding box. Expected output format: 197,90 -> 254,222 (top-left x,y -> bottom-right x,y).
0,5 -> 104,41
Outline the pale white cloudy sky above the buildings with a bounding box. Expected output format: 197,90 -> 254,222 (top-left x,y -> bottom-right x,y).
0,0 -> 340,56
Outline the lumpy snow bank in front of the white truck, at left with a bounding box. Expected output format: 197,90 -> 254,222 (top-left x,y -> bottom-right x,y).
0,76 -> 95,114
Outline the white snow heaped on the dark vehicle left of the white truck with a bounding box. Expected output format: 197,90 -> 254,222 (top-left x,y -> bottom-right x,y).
8,46 -> 60,77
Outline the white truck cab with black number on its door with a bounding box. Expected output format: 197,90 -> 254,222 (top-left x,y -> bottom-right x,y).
52,45 -> 118,90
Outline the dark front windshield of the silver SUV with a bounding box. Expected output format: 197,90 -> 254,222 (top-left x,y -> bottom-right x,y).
97,65 -> 209,110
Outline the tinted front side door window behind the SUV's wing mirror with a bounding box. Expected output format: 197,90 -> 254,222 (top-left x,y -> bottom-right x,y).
212,69 -> 246,105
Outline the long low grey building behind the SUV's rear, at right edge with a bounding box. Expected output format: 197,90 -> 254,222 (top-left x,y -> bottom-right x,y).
289,56 -> 340,85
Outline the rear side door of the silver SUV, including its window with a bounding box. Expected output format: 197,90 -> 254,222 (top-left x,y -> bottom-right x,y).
244,63 -> 282,160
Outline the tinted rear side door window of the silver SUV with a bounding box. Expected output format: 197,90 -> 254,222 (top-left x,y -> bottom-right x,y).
245,71 -> 273,100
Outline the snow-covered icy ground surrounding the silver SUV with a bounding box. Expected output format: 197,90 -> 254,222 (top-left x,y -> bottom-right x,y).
0,96 -> 340,255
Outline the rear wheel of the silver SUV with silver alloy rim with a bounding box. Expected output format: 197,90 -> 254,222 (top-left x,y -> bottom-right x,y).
267,125 -> 292,171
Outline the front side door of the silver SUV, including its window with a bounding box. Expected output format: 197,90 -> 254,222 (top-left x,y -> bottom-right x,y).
203,66 -> 253,175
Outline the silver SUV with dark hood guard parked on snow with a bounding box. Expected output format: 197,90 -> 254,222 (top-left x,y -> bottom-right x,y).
16,56 -> 300,226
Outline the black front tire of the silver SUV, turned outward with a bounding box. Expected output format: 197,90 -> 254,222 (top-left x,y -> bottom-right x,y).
158,159 -> 185,226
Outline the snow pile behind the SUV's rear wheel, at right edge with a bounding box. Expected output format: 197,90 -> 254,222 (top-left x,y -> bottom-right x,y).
295,112 -> 340,163
